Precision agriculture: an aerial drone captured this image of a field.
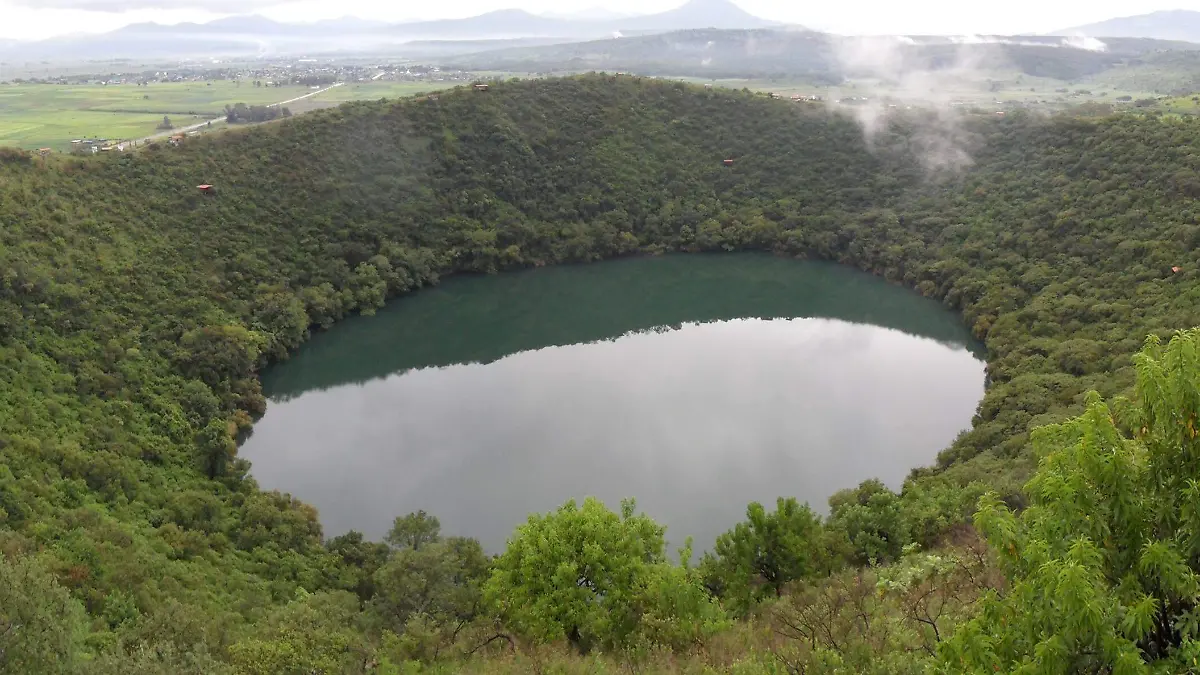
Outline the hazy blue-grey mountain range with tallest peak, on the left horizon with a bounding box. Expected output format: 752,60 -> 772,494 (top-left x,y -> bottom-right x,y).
0,0 -> 776,61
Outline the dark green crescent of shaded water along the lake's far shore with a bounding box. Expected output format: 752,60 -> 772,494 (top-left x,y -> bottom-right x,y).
263,253 -> 983,400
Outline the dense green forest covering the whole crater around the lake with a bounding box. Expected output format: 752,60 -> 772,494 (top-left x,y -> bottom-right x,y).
0,76 -> 1200,675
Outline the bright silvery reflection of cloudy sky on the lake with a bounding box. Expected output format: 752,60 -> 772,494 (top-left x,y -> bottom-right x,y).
242,309 -> 984,551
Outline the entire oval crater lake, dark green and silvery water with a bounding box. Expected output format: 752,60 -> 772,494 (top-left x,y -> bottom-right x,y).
240,255 -> 984,550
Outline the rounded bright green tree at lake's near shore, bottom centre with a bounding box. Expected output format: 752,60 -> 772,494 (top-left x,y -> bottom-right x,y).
485,497 -> 724,651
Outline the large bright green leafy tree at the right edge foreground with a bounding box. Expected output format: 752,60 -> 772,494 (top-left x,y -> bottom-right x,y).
941,330 -> 1200,674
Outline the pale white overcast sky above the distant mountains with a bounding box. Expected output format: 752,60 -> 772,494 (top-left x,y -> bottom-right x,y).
0,0 -> 1200,40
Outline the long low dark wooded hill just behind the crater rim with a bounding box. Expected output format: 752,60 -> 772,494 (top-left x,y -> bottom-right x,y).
446,29 -> 1200,84
